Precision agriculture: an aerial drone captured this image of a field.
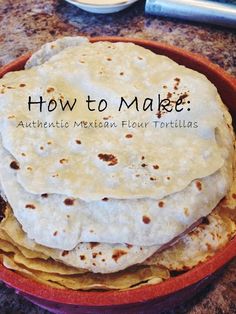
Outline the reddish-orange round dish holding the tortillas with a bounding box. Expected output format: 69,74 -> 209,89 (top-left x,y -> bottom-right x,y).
0,37 -> 236,313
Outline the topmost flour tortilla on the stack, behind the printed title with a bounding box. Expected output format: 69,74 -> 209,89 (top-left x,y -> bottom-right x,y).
0,42 -> 224,202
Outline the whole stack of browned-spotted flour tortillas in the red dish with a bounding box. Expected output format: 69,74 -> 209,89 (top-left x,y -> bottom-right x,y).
0,37 -> 236,290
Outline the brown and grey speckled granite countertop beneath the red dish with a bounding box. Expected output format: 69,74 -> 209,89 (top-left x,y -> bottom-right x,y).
0,0 -> 236,314
